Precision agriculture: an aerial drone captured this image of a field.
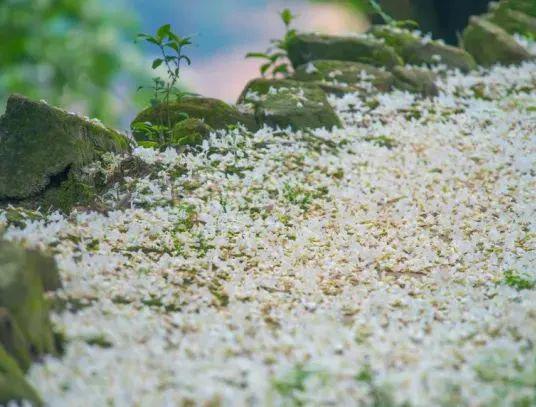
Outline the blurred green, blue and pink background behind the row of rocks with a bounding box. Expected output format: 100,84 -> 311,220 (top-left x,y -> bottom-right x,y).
0,0 -> 488,128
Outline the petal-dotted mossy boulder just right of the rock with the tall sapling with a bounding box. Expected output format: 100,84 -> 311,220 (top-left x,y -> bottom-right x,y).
239,79 -> 341,130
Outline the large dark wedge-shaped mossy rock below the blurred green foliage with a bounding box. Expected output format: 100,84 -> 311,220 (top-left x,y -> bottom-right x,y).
0,95 -> 129,204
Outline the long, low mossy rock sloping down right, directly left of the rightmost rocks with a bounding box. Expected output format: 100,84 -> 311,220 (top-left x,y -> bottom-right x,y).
370,25 -> 476,72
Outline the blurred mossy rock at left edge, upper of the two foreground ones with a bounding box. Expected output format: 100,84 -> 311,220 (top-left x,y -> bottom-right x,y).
0,241 -> 57,358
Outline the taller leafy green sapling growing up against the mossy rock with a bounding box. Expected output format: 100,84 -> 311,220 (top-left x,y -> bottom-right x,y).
133,24 -> 192,147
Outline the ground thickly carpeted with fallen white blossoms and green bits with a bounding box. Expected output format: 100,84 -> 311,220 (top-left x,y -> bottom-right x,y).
0,63 -> 536,406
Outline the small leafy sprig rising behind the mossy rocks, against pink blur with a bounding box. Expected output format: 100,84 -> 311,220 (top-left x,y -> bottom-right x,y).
246,8 -> 296,78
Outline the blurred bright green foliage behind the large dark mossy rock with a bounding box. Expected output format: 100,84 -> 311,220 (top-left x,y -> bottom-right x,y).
0,0 -> 144,124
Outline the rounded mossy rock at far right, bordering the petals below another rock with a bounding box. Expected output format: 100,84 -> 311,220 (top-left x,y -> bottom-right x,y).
463,17 -> 533,66
